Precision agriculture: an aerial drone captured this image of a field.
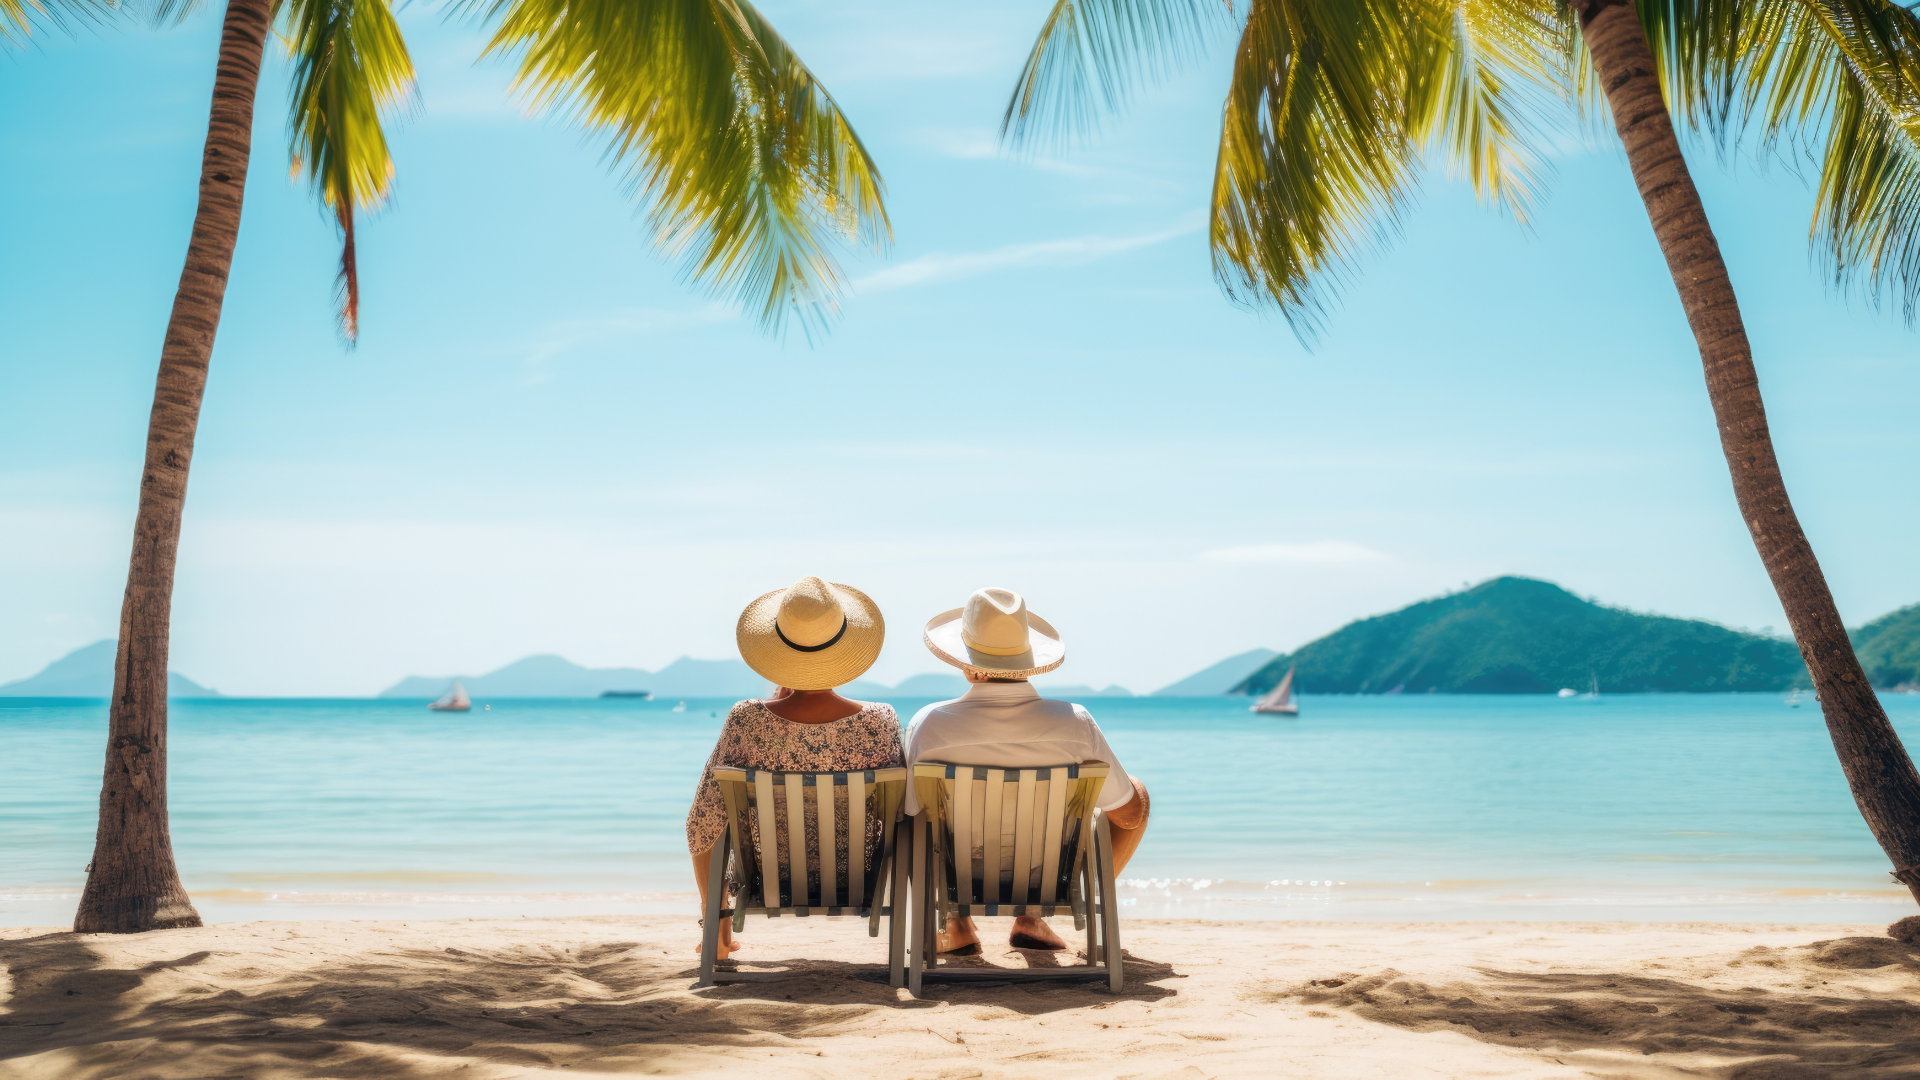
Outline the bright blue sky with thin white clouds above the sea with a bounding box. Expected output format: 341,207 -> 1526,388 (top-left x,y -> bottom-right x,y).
0,0 -> 1920,694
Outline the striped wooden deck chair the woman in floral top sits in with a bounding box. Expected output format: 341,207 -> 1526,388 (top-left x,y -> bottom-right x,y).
699,767 -> 908,986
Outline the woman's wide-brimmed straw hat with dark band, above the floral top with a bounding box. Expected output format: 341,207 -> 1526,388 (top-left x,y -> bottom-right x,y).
733,577 -> 887,690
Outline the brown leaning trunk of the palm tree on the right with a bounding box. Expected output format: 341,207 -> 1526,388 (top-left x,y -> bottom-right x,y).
1572,0 -> 1920,899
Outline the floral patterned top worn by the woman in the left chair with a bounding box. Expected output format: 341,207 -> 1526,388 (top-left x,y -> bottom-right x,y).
687,698 -> 906,857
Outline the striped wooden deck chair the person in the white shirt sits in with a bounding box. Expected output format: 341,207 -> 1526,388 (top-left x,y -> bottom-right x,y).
906,761 -> 1123,994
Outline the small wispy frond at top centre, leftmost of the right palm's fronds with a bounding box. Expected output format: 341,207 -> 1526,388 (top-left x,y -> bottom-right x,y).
1000,0 -> 1233,144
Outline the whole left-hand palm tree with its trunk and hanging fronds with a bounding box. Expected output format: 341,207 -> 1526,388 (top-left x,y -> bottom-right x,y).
67,0 -> 887,932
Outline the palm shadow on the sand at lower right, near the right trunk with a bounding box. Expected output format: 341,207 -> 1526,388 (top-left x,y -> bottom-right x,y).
1273,938 -> 1920,1080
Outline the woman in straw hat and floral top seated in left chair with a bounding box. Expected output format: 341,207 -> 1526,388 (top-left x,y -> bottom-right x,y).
687,577 -> 904,959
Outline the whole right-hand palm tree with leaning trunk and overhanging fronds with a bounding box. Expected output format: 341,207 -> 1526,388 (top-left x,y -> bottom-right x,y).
1002,0 -> 1920,899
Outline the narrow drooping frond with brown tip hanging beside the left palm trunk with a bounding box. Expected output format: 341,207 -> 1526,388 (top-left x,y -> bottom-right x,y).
280,0 -> 415,342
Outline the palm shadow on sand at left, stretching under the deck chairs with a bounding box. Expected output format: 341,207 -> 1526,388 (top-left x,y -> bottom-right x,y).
0,932 -> 1177,1078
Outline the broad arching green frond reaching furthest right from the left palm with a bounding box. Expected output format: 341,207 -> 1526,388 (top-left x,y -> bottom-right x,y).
488,0 -> 891,332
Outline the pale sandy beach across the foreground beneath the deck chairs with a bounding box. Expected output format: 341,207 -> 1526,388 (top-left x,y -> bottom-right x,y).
0,917 -> 1920,1080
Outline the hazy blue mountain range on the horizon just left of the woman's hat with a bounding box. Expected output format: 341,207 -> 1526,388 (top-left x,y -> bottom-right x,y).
380,655 -> 766,698
